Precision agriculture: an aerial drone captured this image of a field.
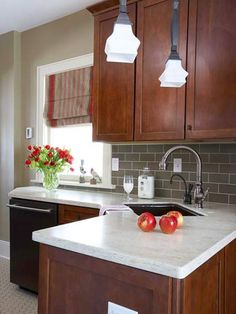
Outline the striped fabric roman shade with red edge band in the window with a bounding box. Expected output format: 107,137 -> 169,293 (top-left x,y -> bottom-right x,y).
44,67 -> 92,127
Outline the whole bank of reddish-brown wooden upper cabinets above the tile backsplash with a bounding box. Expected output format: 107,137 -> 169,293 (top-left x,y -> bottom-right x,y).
89,0 -> 236,142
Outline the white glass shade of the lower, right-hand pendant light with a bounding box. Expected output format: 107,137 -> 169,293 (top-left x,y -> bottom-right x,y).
159,59 -> 188,87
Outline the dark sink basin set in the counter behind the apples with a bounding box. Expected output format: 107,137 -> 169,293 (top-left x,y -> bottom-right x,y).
126,204 -> 203,216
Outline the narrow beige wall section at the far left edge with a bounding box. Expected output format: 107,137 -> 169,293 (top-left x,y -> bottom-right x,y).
0,32 -> 20,240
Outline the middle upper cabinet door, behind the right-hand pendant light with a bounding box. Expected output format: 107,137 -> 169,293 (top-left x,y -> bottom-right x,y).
135,0 -> 187,140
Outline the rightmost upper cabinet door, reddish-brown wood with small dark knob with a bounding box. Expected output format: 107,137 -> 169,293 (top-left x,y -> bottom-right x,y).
186,0 -> 236,139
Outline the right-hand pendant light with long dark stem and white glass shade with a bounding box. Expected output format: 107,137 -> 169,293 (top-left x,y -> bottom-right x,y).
159,0 -> 188,87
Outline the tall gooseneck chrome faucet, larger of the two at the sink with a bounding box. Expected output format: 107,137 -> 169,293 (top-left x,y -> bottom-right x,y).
159,145 -> 208,208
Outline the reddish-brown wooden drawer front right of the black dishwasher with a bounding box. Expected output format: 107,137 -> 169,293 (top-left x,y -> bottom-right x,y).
59,205 -> 99,224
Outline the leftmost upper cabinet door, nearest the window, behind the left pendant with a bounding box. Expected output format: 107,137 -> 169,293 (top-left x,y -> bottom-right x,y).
93,4 -> 136,142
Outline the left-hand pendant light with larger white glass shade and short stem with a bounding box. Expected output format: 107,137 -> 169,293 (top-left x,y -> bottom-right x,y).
105,0 -> 140,63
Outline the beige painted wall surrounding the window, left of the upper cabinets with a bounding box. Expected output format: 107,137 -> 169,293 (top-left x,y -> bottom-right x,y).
0,10 -> 93,240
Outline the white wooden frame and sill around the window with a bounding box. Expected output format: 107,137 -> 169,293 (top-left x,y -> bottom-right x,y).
33,53 -> 115,188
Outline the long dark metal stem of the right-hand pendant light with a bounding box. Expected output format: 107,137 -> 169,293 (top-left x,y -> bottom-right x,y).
169,0 -> 180,60
